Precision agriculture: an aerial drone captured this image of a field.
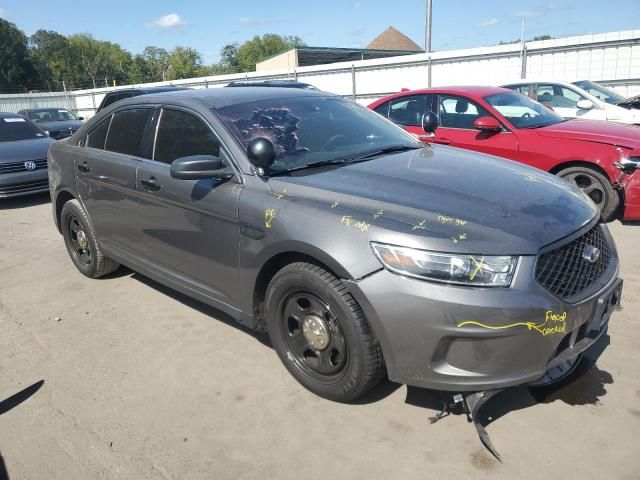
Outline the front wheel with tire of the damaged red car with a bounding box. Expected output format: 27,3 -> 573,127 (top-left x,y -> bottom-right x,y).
558,167 -> 620,222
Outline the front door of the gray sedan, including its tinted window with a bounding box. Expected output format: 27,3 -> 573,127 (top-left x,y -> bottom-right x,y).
136,106 -> 242,305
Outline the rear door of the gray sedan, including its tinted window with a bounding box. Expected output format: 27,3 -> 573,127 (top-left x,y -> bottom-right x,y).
75,106 -> 154,253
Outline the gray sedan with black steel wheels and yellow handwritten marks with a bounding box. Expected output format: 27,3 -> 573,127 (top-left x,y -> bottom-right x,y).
49,87 -> 622,401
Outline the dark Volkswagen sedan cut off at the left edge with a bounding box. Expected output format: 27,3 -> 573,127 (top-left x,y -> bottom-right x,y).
0,112 -> 54,198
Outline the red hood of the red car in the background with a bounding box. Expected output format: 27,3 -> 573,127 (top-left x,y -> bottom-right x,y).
536,119 -> 640,148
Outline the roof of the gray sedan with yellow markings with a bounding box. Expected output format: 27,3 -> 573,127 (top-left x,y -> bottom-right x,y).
114,87 -> 337,108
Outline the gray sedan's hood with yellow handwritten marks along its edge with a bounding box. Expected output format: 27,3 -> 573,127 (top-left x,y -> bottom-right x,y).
269,145 -> 598,255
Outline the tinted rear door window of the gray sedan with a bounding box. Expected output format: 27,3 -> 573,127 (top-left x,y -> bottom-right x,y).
104,108 -> 153,156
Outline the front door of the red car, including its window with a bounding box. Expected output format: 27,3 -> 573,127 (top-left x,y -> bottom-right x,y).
428,94 -> 518,159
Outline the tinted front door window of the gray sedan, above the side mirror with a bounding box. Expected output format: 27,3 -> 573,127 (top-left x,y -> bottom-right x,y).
153,110 -> 220,163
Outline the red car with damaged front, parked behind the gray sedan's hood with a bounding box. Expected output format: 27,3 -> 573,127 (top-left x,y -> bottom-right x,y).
369,87 -> 640,221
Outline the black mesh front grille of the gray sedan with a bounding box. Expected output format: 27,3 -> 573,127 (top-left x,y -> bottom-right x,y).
536,225 -> 612,300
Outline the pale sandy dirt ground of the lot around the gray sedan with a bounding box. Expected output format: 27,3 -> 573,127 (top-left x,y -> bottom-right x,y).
0,192 -> 640,480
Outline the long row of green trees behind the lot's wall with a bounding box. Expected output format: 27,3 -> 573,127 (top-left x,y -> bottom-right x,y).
0,19 -> 304,92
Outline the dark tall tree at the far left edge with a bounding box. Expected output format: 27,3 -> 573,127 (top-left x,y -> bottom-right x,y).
0,18 -> 35,89
